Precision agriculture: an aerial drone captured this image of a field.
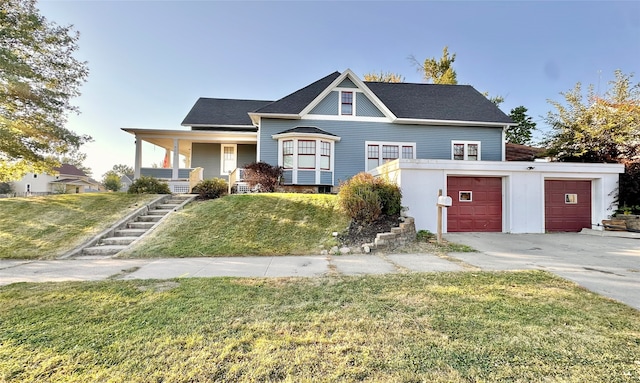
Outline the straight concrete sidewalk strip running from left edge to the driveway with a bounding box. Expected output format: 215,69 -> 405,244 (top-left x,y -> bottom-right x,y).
0,254 -> 464,286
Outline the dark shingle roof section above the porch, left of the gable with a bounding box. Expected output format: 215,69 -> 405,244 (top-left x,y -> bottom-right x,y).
182,97 -> 272,126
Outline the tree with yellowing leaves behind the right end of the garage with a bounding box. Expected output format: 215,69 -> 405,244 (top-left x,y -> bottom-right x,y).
544,70 -> 640,162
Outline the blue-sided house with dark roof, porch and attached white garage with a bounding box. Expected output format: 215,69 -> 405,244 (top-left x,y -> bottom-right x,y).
124,70 -> 622,232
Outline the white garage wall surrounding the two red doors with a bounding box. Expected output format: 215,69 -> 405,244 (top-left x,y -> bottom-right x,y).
371,159 -> 624,233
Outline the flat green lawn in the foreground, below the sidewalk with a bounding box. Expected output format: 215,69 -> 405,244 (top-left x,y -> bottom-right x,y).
0,271 -> 640,382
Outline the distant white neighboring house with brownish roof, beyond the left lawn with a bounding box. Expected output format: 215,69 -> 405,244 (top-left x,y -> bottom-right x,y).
13,164 -> 104,195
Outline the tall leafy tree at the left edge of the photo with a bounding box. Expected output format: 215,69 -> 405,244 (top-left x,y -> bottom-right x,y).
0,0 -> 91,181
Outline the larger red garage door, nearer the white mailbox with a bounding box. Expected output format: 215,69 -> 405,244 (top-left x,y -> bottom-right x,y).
447,177 -> 502,232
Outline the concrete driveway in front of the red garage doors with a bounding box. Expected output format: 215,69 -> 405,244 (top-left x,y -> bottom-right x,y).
445,233 -> 640,310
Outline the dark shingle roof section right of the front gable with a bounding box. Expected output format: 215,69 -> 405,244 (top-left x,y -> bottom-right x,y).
365,82 -> 513,123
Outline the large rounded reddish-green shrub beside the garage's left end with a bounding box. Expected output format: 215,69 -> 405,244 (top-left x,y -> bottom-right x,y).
338,172 -> 402,223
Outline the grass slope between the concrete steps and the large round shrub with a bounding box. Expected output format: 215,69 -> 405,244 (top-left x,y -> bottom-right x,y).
123,193 -> 349,257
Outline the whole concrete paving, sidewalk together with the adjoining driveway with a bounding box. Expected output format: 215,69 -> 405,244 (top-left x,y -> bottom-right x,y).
0,233 -> 640,310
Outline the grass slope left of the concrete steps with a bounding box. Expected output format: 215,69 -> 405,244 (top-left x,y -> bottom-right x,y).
0,193 -> 157,259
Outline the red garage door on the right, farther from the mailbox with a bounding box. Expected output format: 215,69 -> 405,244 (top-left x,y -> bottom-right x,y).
544,180 -> 591,231
